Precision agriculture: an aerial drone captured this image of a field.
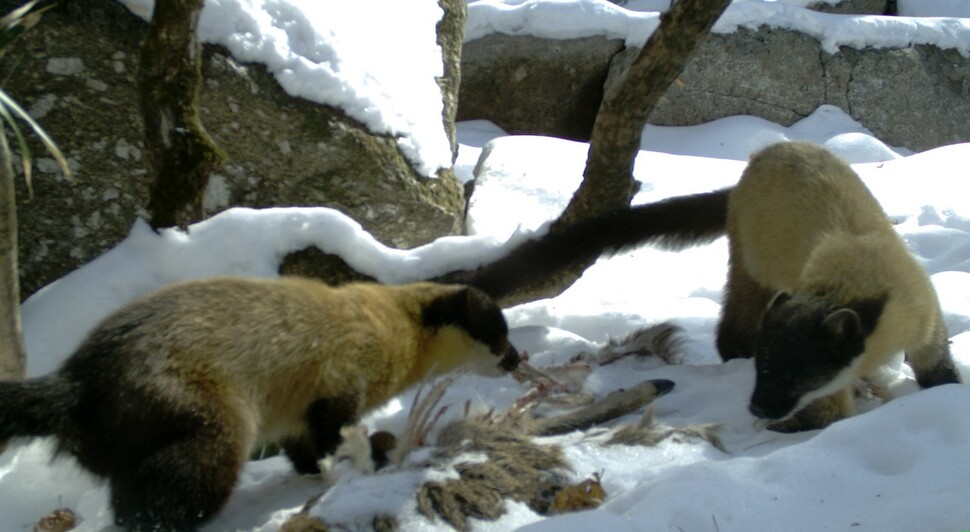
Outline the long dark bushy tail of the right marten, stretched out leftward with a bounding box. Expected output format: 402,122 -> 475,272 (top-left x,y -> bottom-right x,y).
459,189 -> 730,299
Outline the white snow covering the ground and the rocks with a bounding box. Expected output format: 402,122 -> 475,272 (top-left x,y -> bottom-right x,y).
0,0 -> 970,532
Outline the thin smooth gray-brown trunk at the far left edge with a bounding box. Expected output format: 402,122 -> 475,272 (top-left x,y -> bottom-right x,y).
0,122 -> 27,380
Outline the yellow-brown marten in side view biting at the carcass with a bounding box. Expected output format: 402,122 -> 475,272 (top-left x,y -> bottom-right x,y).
0,278 -> 519,530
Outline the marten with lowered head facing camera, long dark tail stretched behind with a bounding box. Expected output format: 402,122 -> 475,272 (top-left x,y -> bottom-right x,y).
461,142 -> 959,430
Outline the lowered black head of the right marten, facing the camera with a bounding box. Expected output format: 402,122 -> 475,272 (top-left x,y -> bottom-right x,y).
749,292 -> 883,426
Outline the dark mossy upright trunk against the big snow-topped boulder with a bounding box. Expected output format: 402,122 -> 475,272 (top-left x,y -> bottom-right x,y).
139,0 -> 226,229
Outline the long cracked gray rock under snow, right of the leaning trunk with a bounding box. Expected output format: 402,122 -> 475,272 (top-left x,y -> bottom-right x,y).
607,26 -> 970,151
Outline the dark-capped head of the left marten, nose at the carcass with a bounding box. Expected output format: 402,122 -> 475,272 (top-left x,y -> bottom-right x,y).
421,286 -> 519,373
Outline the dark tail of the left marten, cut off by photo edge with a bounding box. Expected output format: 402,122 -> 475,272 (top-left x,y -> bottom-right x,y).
0,373 -> 75,446
